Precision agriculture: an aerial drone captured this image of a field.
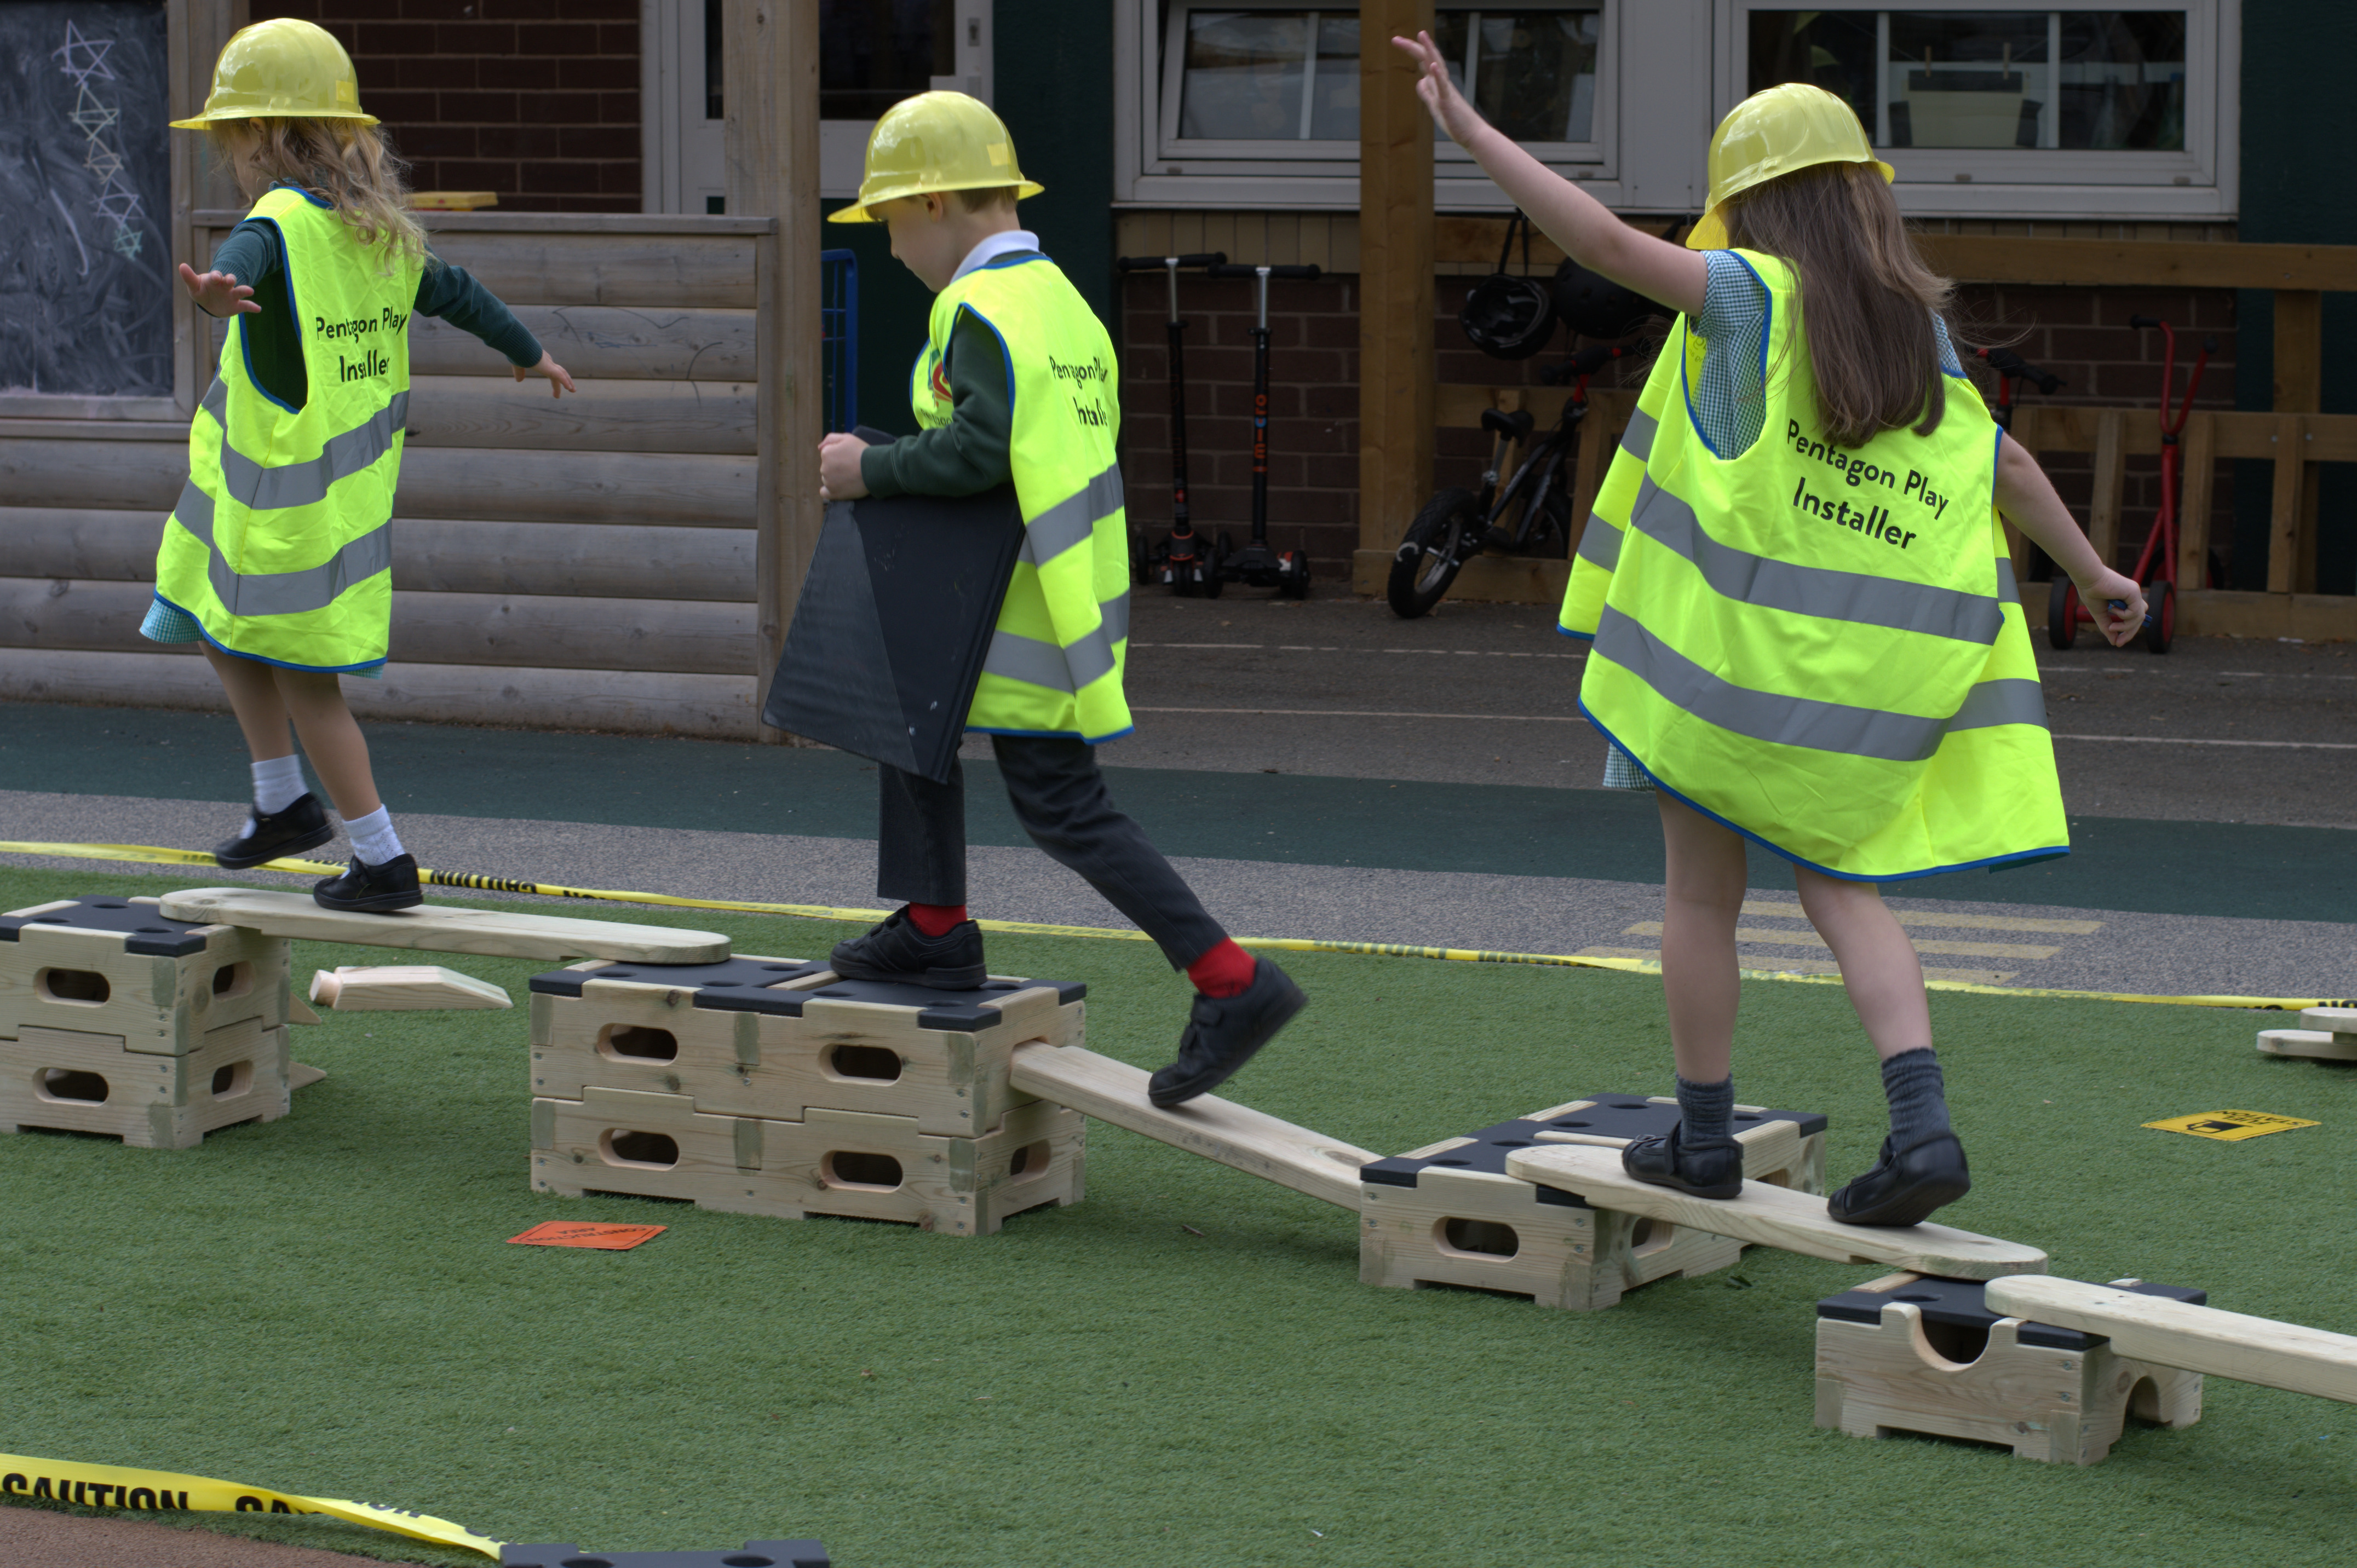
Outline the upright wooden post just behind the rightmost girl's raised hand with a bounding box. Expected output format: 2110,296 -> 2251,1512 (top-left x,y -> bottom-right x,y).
1358,0 -> 1438,568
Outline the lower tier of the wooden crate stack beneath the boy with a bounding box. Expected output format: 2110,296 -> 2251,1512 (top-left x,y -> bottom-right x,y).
533,1087 -> 1086,1236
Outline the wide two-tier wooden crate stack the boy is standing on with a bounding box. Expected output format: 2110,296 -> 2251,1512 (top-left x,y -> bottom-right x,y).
530,955 -> 1086,1236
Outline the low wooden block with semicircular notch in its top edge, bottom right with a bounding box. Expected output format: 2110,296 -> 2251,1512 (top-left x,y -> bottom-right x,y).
1817,1273 -> 2206,1465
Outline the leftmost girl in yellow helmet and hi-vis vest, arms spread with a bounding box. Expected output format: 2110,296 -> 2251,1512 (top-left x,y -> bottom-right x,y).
139,19 -> 573,910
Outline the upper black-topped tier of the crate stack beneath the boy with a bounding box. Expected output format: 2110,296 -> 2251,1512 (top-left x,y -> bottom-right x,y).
530,955 -> 1086,1137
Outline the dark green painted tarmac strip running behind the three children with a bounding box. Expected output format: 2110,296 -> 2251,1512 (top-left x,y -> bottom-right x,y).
0,702 -> 2357,922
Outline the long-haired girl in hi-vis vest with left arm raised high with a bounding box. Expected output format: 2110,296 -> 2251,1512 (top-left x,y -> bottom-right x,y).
1395,36 -> 2145,1226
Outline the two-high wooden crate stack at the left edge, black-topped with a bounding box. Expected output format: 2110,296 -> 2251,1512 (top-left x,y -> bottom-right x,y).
0,898 -> 290,1148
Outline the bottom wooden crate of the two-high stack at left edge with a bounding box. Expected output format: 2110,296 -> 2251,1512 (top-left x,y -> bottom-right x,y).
0,1019 -> 290,1148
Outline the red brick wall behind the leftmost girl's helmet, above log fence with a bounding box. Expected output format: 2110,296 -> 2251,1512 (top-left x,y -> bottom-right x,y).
252,0 -> 641,212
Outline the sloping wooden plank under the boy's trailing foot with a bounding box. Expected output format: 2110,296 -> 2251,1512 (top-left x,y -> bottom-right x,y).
1009,1045 -> 1383,1214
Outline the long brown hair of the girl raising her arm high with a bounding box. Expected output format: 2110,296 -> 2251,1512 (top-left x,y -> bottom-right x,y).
1726,163 -> 1956,448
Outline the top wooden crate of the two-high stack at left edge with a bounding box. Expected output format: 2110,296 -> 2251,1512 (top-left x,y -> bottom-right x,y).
0,898 -> 290,1056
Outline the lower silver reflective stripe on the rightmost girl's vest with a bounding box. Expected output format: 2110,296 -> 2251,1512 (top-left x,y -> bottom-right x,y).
1596,606 -> 2046,762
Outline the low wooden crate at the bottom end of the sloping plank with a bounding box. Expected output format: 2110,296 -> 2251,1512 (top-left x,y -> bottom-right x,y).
1358,1094 -> 1824,1311
